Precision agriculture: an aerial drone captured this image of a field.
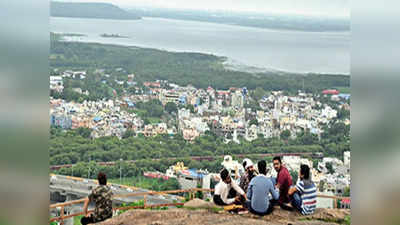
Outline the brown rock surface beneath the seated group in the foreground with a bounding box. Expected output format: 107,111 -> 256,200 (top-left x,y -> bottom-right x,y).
95,208 -> 350,225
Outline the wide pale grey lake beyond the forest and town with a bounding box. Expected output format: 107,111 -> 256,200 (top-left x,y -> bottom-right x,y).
50,17 -> 350,74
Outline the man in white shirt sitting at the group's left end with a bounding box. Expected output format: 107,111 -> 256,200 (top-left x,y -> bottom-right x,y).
213,169 -> 246,205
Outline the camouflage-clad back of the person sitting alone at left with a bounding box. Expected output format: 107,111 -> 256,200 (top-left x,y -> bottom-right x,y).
89,185 -> 113,222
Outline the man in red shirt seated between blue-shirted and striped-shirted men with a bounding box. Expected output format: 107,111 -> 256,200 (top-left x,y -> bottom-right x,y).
272,156 -> 292,206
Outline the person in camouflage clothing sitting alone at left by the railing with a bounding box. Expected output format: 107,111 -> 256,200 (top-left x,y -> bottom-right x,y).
81,172 -> 113,225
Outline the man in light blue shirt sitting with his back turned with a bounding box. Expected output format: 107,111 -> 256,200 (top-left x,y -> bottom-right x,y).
246,160 -> 279,216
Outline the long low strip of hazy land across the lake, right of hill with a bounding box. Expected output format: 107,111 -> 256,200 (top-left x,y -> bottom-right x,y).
127,8 -> 350,32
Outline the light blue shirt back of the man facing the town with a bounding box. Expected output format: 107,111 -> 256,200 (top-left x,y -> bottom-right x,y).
247,175 -> 279,213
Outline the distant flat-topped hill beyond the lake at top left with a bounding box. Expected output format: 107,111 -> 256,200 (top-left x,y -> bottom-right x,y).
50,1 -> 140,20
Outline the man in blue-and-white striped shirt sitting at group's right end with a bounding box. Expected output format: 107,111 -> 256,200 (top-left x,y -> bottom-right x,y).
289,165 -> 317,215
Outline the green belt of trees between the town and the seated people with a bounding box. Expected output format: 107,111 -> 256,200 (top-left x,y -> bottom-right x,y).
49,117 -> 350,177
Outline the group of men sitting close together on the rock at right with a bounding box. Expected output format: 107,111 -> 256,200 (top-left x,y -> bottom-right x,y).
213,156 -> 317,216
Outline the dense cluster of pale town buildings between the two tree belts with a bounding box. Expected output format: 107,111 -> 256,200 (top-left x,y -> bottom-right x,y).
50,70 -> 350,143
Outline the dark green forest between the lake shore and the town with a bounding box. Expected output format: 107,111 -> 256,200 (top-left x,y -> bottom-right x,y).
50,37 -> 350,96
